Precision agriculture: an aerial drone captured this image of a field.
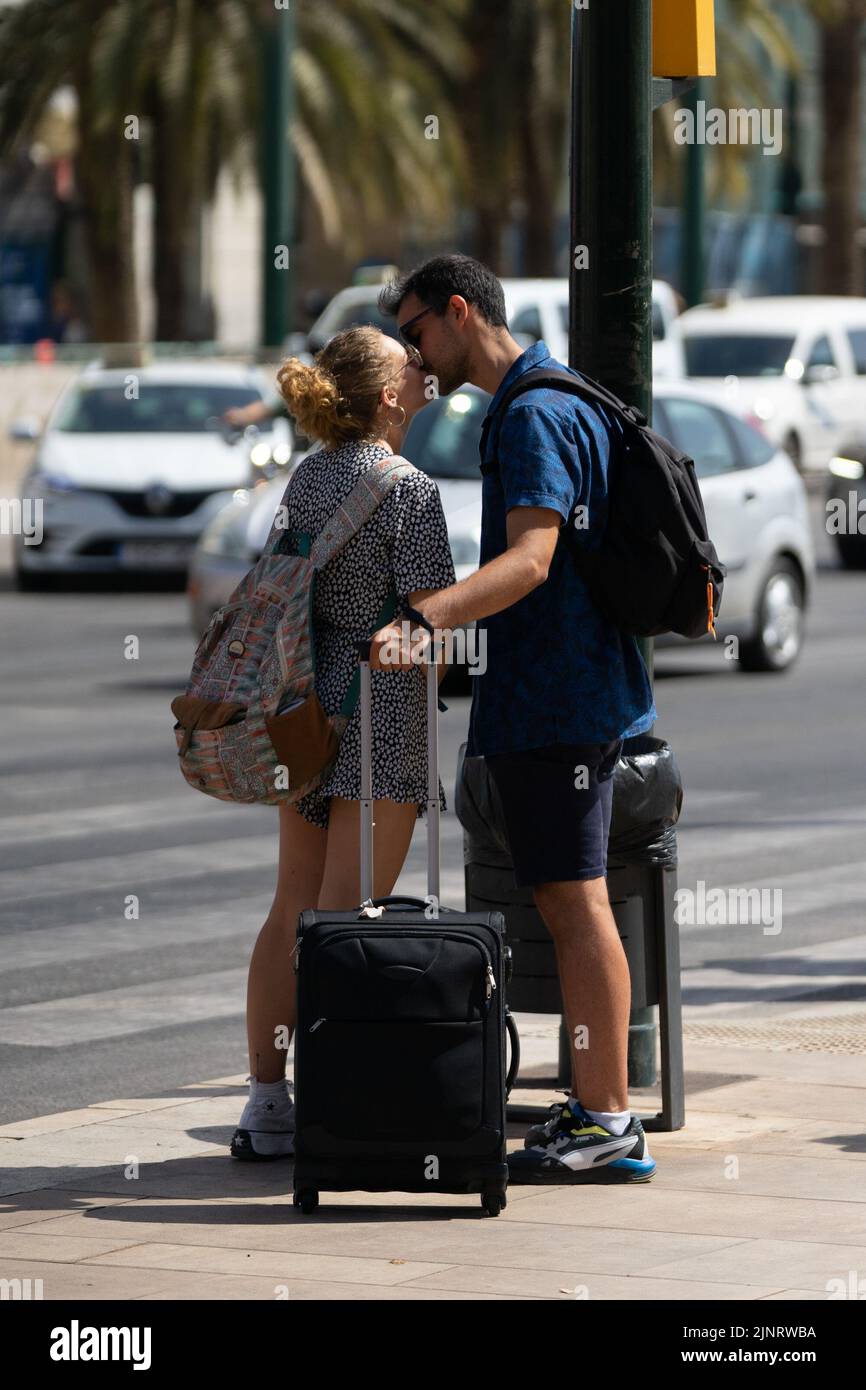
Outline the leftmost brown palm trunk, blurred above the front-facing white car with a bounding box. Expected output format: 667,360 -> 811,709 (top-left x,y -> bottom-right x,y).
75,64 -> 140,343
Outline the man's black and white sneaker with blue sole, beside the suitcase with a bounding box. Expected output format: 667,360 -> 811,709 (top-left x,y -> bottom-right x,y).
509,1101 -> 656,1183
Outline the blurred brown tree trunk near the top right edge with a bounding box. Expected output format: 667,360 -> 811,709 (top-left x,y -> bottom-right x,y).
819,0 -> 866,295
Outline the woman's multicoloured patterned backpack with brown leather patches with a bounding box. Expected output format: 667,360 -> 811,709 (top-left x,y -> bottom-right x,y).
171,455 -> 416,806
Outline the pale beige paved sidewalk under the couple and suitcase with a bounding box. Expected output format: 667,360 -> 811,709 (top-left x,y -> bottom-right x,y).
0,1001 -> 866,1301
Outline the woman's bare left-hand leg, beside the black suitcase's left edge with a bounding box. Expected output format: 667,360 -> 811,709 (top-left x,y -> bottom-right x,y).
246,806 -> 328,1083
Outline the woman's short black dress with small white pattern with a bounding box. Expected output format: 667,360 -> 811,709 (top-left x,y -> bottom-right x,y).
284,443 -> 455,827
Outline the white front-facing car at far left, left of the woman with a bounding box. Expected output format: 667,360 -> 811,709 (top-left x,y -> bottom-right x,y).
10,363 -> 291,589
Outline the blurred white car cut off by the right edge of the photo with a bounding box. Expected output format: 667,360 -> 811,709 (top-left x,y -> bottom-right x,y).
671,295 -> 866,473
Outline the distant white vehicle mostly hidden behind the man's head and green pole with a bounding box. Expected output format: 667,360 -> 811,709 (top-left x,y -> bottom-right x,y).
301,277 -> 683,377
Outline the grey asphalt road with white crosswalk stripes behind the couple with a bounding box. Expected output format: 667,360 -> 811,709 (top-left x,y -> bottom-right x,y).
0,499 -> 866,1123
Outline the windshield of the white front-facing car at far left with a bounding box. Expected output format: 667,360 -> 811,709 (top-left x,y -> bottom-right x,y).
53,381 -> 271,434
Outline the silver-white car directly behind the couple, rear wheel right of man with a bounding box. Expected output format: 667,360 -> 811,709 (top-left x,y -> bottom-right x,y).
189,382 -> 815,671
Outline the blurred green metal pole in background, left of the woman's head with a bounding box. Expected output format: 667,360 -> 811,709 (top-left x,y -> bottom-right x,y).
260,0 -> 296,348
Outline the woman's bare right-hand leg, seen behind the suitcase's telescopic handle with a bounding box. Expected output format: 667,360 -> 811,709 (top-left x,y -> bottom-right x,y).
318,796 -> 418,912
